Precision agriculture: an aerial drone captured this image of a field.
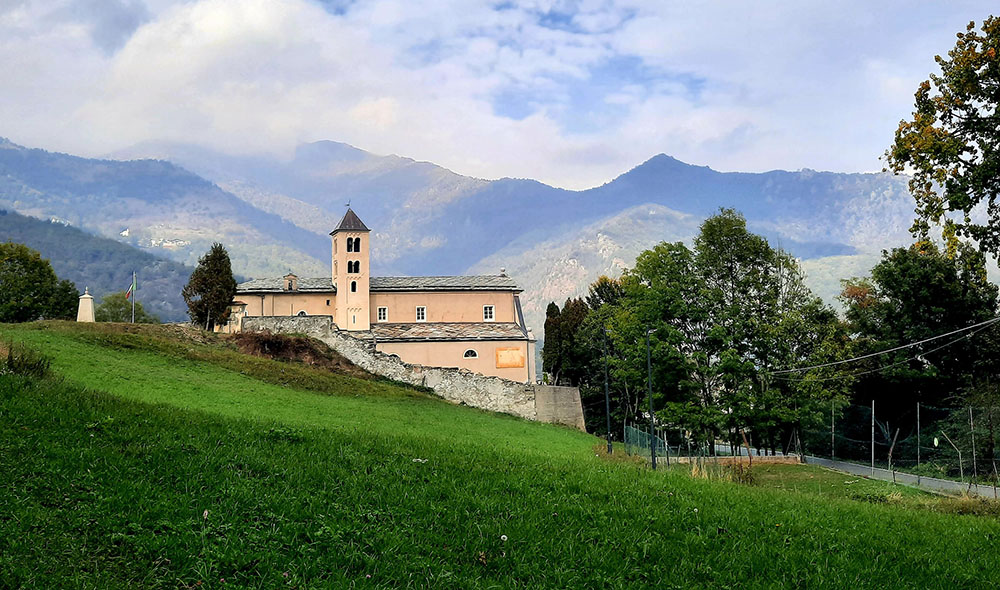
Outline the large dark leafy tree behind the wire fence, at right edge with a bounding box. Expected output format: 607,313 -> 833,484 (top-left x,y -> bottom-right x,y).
841,242 -> 1000,468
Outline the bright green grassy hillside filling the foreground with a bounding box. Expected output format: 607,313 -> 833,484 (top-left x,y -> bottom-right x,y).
0,323 -> 1000,588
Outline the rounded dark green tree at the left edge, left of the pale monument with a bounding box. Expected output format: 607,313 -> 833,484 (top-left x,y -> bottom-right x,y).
0,242 -> 80,322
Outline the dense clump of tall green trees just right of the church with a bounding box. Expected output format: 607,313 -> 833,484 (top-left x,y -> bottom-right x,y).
568,209 -> 848,448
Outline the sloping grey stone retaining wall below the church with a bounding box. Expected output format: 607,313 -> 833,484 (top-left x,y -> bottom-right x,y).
243,316 -> 584,430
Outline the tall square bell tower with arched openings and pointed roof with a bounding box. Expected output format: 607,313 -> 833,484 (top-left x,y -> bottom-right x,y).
330,207 -> 371,331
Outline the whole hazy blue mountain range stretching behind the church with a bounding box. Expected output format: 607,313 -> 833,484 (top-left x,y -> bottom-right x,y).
0,140 -> 913,333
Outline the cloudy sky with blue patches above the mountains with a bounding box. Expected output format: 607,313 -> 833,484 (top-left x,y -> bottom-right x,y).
0,0 -> 1000,189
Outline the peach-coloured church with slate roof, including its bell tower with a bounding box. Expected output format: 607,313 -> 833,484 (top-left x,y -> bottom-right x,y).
225,208 -> 536,383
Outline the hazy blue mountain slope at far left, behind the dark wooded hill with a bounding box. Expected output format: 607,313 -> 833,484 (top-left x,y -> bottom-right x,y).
0,142 -> 329,274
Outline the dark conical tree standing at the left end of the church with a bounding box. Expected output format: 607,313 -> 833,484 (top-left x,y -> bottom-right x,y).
181,242 -> 236,330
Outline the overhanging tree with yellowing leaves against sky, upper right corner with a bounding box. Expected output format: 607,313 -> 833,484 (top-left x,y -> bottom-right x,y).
885,16 -> 1000,255
